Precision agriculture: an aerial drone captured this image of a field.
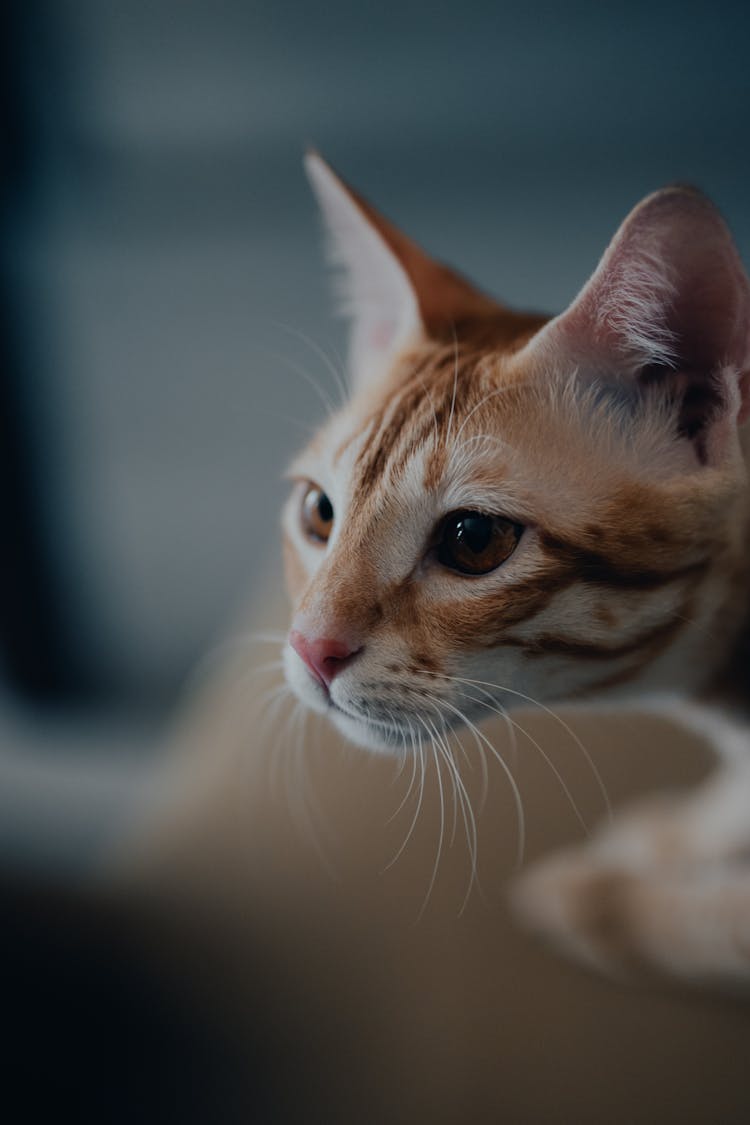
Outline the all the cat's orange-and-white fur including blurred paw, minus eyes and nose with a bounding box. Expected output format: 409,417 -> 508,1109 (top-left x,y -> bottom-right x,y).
279,159 -> 750,984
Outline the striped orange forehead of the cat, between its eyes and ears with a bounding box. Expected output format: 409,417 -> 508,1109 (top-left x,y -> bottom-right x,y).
290,347 -> 697,537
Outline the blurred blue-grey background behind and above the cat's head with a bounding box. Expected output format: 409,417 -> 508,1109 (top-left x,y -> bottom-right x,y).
0,0 -> 750,1119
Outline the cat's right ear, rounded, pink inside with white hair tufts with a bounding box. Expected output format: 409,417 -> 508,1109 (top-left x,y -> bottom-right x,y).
530,187 -> 750,461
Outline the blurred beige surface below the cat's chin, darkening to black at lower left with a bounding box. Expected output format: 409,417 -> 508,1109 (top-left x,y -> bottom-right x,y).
3,576 -> 750,1125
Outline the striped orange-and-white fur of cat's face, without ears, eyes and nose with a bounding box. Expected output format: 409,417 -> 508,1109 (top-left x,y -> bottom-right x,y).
286,333 -> 744,745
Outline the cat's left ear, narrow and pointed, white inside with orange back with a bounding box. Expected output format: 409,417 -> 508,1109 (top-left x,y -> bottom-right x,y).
305,152 -> 494,385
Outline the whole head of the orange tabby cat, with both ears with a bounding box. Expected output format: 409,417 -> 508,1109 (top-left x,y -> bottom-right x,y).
283,154 -> 750,748
